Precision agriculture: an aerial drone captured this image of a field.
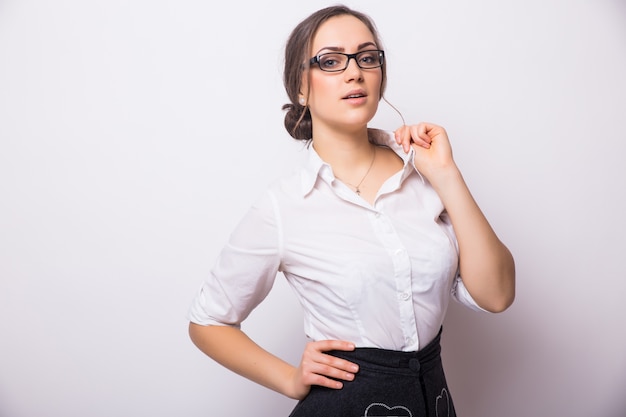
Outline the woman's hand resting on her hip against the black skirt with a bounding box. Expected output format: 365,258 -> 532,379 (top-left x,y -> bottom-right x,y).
289,340 -> 359,400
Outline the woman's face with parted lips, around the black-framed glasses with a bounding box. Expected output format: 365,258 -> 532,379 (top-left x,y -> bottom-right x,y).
301,15 -> 382,135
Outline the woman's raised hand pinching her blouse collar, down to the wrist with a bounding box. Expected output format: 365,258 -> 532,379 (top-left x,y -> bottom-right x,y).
395,122 -> 455,180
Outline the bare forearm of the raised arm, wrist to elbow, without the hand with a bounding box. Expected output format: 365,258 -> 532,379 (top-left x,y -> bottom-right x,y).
431,166 -> 515,312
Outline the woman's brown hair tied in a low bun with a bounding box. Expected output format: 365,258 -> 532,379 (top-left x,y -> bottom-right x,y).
283,5 -> 387,140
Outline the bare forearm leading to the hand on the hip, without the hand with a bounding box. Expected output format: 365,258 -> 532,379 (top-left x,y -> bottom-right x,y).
189,323 -> 296,398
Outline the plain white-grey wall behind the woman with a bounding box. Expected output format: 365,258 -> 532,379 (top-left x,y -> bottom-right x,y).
0,0 -> 626,417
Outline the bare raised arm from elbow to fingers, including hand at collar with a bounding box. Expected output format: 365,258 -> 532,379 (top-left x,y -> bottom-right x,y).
395,123 -> 515,312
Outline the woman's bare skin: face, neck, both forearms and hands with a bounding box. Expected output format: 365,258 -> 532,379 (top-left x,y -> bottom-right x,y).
189,15 -> 515,399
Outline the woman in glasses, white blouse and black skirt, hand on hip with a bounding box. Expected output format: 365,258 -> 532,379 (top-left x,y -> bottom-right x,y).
190,6 -> 515,417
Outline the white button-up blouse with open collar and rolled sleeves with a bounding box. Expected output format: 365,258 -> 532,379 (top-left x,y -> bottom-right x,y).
188,131 -> 482,351
